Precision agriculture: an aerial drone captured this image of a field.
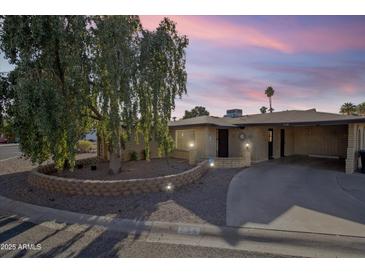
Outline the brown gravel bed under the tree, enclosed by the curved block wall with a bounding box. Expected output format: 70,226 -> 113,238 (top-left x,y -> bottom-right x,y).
53,159 -> 192,180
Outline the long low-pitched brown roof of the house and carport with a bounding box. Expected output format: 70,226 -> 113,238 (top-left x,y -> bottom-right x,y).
169,109 -> 365,127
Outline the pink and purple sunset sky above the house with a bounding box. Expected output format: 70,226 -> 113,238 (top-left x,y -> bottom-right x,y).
0,16 -> 365,117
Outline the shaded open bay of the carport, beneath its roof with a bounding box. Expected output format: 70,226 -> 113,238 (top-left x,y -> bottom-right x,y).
268,124 -> 348,172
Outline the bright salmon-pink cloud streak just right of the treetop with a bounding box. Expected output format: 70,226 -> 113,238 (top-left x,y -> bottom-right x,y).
140,16 -> 292,53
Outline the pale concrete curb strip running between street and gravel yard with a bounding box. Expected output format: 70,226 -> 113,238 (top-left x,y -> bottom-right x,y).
0,196 -> 365,257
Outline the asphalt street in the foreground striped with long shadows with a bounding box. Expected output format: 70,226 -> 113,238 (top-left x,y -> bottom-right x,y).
0,214 -> 277,258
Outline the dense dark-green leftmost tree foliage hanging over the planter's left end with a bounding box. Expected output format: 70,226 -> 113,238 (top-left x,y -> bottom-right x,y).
0,16 -> 95,168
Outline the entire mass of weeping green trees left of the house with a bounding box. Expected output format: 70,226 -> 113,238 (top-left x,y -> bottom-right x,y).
0,16 -> 188,172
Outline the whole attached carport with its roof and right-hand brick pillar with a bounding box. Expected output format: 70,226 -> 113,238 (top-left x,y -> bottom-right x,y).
232,109 -> 365,173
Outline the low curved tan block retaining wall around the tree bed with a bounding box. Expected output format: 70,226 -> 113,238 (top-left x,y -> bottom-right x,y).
28,158 -> 209,196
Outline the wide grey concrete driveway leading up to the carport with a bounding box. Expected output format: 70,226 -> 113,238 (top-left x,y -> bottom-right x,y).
226,157 -> 365,237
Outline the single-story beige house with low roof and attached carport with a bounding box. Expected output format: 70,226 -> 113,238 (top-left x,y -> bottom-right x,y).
169,109 -> 365,173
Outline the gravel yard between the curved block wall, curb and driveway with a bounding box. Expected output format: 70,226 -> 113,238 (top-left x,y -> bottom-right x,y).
0,155 -> 240,225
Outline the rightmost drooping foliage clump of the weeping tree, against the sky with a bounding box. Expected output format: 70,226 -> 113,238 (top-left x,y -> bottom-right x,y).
137,18 -> 189,167
